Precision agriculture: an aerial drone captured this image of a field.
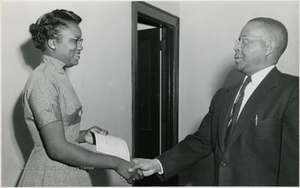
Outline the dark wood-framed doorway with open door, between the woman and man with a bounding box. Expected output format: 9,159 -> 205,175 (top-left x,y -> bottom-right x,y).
132,2 -> 179,186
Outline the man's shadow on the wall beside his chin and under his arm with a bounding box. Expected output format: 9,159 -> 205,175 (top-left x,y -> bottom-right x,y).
179,63 -> 244,186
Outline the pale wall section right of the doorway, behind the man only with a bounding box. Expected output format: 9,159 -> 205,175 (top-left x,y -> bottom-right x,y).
179,1 -> 299,185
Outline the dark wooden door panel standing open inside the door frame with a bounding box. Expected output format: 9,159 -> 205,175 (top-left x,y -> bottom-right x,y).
135,28 -> 161,186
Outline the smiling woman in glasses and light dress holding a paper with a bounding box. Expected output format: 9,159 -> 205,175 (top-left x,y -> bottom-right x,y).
19,10 -> 139,186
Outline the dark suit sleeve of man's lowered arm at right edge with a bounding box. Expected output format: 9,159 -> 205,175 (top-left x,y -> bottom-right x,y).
278,81 -> 299,186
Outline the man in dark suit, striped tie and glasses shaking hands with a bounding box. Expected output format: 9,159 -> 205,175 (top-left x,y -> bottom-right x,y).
129,18 -> 299,186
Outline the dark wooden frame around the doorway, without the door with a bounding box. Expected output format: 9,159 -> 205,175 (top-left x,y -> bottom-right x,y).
132,2 -> 179,157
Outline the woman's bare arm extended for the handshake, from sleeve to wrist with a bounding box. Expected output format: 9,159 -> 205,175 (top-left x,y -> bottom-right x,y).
40,121 -> 124,169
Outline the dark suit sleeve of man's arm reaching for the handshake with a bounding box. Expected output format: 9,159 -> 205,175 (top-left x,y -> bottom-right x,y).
157,91 -> 220,181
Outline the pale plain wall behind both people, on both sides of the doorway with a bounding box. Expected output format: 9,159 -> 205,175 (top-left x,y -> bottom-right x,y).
1,1 -> 299,186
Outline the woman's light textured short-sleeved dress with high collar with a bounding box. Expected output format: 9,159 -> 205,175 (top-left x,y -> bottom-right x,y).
18,55 -> 92,186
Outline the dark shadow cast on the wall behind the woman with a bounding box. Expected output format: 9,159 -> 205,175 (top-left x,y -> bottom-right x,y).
13,39 -> 110,186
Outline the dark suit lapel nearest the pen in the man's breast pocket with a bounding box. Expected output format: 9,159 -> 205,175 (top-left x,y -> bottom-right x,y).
224,67 -> 281,152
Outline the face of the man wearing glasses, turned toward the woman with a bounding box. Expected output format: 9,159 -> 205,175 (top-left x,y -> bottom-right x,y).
234,22 -> 267,76
